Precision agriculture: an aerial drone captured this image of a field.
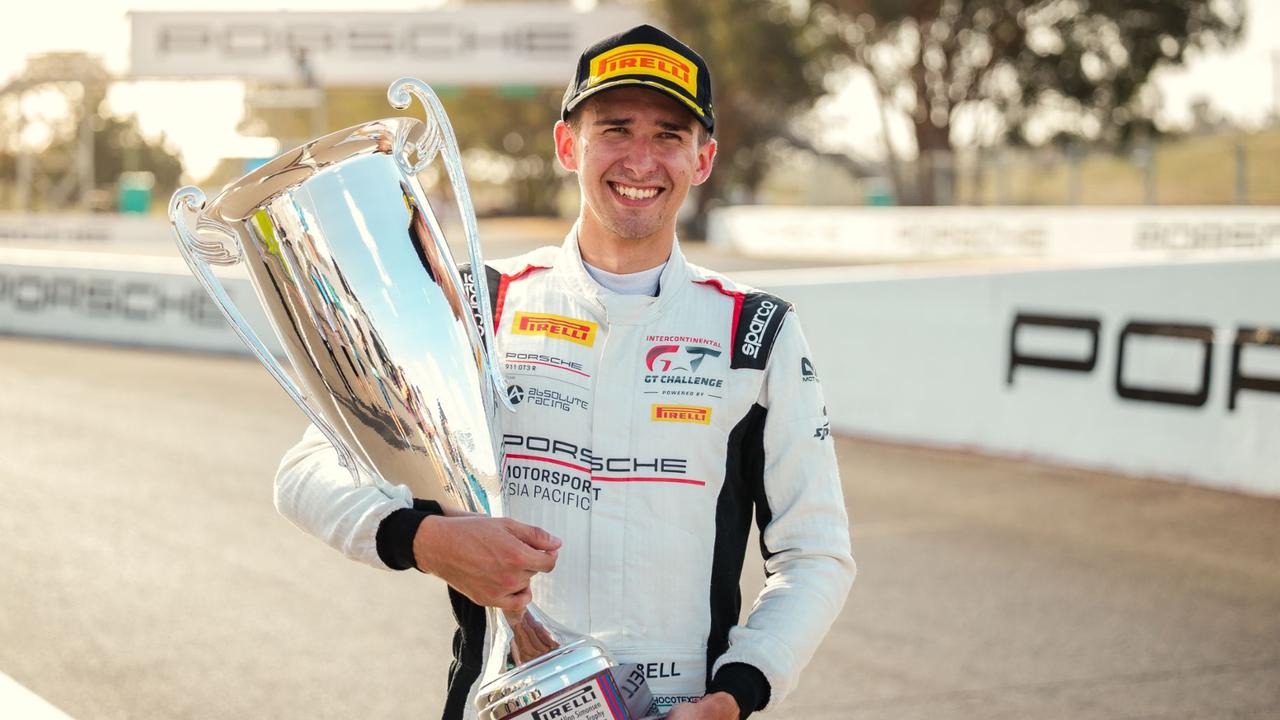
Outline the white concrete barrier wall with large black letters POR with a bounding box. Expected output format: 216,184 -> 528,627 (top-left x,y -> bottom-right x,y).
744,259 -> 1280,495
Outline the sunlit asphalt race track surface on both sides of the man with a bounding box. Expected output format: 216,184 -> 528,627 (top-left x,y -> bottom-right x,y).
0,338 -> 1280,720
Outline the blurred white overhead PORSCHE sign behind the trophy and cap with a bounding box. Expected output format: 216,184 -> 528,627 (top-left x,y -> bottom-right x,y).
129,5 -> 644,86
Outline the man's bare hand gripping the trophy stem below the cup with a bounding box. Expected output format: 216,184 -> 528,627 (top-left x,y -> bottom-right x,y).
413,514 -> 561,612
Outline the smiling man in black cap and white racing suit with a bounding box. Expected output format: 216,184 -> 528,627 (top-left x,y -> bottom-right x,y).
276,26 -> 854,720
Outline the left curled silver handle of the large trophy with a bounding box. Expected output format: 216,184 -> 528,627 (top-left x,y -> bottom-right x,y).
169,186 -> 366,486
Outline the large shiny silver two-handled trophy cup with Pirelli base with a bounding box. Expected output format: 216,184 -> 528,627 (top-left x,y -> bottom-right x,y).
169,78 -> 652,720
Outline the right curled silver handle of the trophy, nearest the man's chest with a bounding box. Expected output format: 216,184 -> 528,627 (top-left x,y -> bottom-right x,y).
387,77 -> 516,411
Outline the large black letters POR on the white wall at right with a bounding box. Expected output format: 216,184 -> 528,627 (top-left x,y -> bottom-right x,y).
1005,313 -> 1280,411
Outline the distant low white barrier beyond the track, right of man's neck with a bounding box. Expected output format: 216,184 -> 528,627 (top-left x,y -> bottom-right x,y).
707,205 -> 1280,261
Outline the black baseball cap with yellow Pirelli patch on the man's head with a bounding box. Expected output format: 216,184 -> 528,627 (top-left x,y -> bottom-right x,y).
561,26 -> 716,132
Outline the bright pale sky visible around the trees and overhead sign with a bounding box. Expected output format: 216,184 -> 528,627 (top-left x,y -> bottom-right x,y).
0,0 -> 1280,178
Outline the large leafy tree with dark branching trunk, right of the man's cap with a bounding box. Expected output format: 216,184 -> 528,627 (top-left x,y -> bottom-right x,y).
810,0 -> 1244,205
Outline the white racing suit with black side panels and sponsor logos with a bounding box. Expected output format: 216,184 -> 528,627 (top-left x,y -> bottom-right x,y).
276,233 -> 854,720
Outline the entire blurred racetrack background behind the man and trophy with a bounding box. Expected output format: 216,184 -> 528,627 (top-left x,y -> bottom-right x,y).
0,0 -> 1280,719
